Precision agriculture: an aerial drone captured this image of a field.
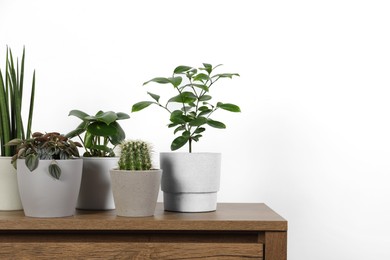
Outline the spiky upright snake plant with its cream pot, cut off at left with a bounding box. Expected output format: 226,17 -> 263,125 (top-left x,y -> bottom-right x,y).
0,47 -> 35,210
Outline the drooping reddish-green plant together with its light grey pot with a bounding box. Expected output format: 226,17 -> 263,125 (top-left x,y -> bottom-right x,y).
7,132 -> 83,217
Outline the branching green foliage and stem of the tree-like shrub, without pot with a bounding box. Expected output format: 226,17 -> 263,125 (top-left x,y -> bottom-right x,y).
132,63 -> 241,153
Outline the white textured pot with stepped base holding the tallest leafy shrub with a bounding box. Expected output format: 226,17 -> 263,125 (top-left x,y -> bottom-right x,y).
160,152 -> 221,212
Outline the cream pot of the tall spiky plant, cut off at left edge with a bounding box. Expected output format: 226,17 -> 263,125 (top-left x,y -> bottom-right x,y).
0,156 -> 23,210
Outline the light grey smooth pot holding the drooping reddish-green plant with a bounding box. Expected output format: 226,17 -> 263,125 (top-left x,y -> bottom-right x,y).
17,159 -> 83,218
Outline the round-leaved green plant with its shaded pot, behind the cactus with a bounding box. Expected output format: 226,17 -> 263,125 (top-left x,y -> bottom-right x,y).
66,110 -> 129,210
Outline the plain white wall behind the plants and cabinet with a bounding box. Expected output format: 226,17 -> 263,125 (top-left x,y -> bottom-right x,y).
0,0 -> 390,260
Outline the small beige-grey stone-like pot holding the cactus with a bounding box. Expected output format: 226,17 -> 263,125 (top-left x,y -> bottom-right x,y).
110,169 -> 162,217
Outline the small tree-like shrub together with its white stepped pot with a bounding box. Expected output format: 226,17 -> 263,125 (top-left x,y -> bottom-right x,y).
132,63 -> 240,212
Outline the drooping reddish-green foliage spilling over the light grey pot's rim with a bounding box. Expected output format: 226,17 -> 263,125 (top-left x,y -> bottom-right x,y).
6,132 -> 82,180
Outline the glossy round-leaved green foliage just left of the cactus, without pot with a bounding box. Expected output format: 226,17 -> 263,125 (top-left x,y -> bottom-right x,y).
66,110 -> 130,157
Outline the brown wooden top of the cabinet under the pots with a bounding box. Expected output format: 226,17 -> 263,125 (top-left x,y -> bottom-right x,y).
0,203 -> 287,232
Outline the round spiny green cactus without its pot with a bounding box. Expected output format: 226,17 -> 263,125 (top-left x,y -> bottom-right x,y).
118,140 -> 152,171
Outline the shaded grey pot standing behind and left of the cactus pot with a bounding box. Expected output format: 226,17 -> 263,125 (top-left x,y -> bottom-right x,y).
77,157 -> 119,210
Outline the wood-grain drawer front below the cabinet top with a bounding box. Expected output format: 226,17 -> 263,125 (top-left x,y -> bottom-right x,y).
0,243 -> 263,260
